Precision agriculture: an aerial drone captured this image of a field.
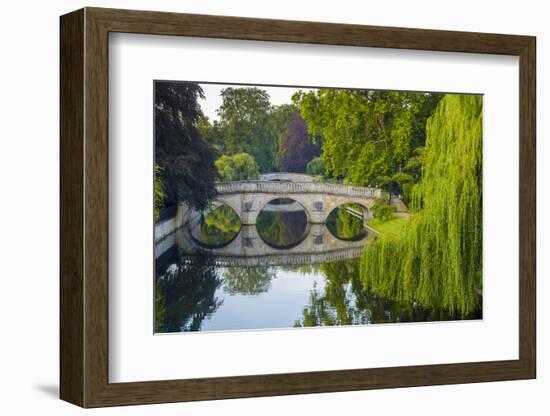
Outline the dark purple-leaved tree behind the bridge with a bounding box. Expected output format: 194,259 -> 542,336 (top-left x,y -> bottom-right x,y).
281,113 -> 321,173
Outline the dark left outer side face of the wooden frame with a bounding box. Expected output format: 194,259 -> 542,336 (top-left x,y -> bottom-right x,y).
59,10 -> 85,406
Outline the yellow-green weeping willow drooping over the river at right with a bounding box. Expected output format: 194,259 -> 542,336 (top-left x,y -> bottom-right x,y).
361,95 -> 482,317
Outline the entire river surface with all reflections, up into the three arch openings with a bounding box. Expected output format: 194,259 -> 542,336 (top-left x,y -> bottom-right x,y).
155,200 -> 480,332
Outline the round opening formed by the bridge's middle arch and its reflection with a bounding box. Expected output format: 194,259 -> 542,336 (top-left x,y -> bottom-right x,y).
256,198 -> 308,249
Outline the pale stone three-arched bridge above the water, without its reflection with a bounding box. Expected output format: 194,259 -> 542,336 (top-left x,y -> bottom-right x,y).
207,180 -> 381,225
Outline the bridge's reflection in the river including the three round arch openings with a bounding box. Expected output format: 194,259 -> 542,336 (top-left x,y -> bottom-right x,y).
155,199 -> 369,267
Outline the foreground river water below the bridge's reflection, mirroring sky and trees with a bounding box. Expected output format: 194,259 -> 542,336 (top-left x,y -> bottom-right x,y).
155,249 -> 479,332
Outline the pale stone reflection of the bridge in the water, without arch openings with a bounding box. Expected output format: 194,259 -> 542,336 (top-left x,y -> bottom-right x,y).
155,224 -> 369,267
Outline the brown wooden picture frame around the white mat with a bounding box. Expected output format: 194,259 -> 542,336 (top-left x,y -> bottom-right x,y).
60,8 -> 536,407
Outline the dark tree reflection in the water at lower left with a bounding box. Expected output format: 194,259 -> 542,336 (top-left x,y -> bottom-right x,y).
155,253 -> 223,332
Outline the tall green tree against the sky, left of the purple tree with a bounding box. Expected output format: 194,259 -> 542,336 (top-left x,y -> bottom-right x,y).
218,88 -> 277,172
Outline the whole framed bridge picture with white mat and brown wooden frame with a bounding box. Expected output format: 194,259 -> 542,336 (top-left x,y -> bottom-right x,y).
60,8 -> 536,407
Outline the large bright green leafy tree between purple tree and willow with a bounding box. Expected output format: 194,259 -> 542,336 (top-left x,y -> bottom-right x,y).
293,89 -> 441,186
